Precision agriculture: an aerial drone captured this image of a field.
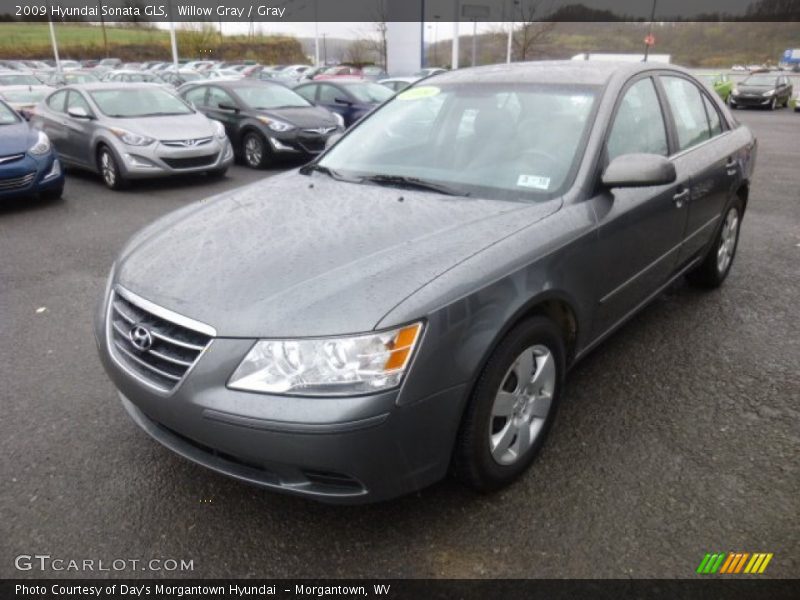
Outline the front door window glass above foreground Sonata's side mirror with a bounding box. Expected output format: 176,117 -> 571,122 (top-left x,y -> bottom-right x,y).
606,77 -> 668,160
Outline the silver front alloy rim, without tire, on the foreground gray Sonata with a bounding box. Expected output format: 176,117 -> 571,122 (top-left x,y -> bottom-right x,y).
489,345 -> 557,465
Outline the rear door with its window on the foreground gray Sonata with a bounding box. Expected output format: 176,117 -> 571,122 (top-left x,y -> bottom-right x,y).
660,74 -> 739,265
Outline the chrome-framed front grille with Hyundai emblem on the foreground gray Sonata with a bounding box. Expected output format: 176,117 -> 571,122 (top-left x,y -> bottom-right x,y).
109,293 -> 211,392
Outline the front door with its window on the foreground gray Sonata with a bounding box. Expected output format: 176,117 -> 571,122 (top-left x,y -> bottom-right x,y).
594,75 -> 691,335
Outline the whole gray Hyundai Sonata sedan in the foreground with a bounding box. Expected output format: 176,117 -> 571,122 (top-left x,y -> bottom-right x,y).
96,62 -> 756,503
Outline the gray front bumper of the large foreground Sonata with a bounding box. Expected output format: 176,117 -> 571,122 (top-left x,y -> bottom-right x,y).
95,286 -> 465,504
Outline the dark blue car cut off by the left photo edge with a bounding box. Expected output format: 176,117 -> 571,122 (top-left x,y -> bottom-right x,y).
0,100 -> 64,200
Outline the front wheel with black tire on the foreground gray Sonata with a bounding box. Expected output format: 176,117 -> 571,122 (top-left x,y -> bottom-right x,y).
453,316 -> 566,492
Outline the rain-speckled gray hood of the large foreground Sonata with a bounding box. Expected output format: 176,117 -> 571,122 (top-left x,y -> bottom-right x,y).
116,171 -> 561,338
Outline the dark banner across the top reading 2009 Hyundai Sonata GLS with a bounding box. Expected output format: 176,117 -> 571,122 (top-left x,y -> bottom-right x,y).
0,0 -> 800,22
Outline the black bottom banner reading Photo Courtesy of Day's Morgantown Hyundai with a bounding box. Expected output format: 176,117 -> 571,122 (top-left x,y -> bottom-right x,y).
0,578 -> 800,600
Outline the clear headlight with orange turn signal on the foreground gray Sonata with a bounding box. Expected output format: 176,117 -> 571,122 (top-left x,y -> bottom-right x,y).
228,323 -> 422,396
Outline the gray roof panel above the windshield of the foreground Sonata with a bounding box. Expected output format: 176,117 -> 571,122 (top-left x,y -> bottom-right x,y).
435,60 -> 687,85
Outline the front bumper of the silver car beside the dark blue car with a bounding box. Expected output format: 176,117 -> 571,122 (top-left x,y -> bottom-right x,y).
113,138 -> 233,179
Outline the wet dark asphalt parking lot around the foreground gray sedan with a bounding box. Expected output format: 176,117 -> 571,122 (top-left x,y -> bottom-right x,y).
0,110 -> 800,578
